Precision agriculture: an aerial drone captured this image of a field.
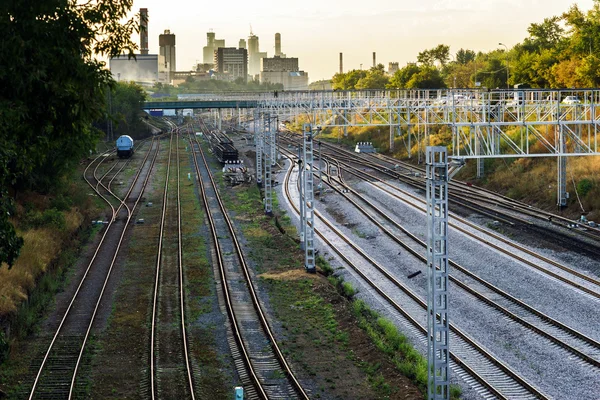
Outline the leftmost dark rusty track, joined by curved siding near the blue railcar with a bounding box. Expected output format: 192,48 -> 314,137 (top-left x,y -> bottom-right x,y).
29,139 -> 159,399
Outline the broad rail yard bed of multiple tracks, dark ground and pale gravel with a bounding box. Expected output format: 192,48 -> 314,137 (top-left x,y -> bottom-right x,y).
2,117 -> 600,399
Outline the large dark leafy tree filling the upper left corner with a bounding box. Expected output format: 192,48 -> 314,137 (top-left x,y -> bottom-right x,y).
0,0 -> 138,266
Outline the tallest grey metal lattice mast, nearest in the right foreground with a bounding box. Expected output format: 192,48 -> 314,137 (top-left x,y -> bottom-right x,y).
426,146 -> 450,400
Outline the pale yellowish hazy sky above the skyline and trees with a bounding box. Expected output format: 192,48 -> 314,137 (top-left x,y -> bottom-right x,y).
133,0 -> 593,82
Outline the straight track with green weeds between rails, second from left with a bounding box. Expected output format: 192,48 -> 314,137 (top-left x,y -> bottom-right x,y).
150,133 -> 195,399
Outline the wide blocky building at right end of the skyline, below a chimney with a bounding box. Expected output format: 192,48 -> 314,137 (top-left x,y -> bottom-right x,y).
260,56 -> 308,90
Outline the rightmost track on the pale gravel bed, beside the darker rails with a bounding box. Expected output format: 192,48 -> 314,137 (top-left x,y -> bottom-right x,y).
278,135 -> 600,299
